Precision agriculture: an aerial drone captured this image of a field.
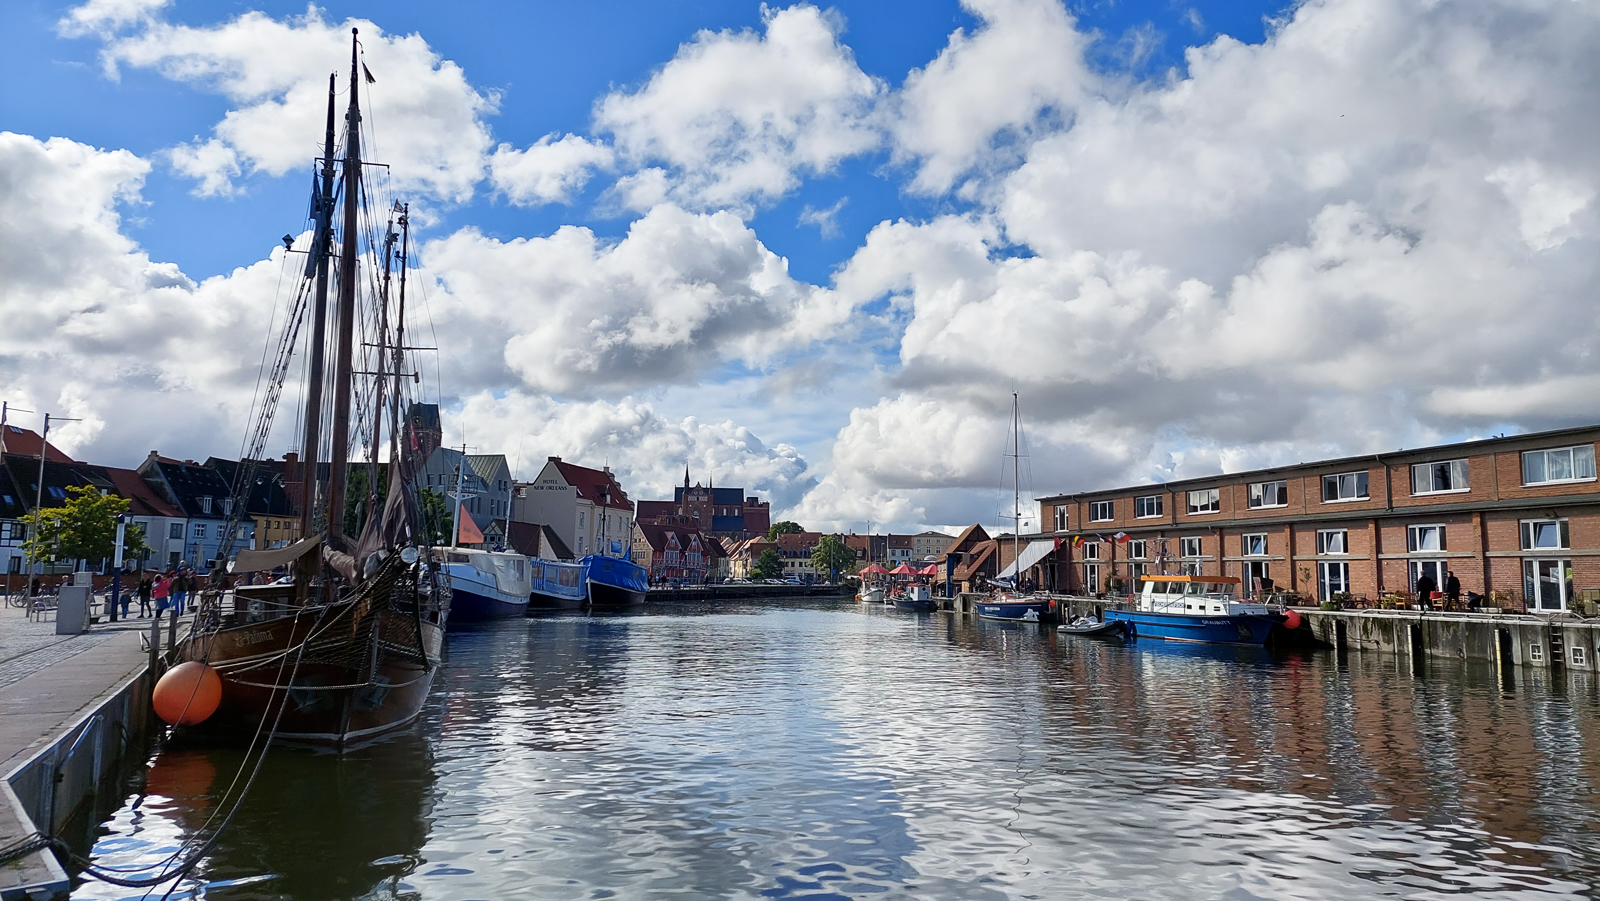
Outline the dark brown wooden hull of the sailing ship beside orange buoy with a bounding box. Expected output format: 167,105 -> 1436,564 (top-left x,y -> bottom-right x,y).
179,602 -> 445,746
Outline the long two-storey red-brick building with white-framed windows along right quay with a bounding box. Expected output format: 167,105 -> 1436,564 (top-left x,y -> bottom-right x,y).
1035,426 -> 1600,611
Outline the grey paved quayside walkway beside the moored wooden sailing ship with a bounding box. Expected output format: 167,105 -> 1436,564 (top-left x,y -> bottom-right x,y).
0,607 -> 150,896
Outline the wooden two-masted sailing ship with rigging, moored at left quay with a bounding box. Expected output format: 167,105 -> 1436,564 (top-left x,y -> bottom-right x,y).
173,29 -> 451,746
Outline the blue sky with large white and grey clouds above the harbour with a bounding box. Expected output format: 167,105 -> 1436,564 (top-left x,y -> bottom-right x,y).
0,0 -> 1600,528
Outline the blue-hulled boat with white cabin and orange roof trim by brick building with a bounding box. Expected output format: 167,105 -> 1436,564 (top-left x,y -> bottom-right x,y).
1106,576 -> 1283,645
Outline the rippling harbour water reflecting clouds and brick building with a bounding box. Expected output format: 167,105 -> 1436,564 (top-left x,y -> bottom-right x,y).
74,605 -> 1600,901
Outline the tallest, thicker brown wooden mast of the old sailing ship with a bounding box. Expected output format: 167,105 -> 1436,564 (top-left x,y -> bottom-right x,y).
328,29 -> 362,535
